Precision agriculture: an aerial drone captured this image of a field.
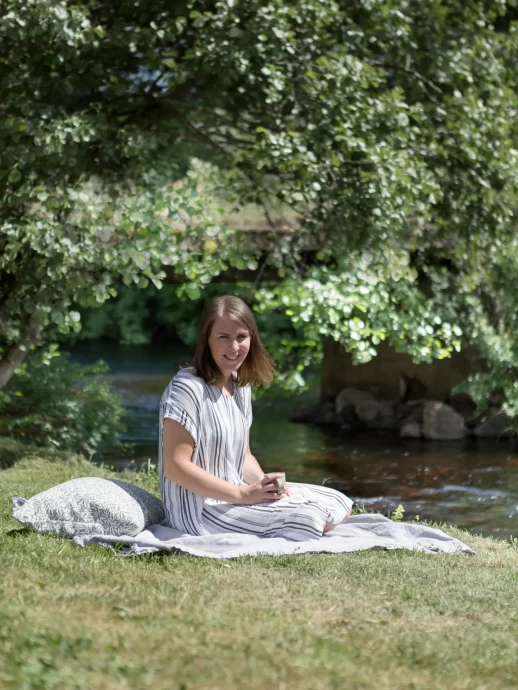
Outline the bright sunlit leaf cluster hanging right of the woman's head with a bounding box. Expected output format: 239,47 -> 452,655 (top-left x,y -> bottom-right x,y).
256,250 -> 468,374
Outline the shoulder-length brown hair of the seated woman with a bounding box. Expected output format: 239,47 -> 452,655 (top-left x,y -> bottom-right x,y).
186,295 -> 275,386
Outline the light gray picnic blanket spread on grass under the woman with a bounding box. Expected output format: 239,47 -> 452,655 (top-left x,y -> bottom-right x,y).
73,513 -> 475,558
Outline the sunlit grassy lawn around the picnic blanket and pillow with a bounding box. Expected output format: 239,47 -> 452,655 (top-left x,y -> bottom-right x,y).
0,440 -> 518,690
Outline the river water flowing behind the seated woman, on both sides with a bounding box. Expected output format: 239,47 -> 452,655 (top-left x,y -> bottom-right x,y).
71,342 -> 518,539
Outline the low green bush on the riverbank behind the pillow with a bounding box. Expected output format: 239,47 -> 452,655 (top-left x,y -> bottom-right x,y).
0,355 -> 126,456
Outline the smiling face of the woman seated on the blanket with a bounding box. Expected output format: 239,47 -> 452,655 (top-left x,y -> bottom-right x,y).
209,316 -> 250,378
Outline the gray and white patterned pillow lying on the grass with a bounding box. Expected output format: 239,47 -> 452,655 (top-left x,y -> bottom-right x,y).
12,477 -> 165,537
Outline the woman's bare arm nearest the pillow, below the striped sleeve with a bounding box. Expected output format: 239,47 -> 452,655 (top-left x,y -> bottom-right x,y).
162,419 -> 241,503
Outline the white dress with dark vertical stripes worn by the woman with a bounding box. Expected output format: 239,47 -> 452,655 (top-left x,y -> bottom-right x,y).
159,368 -> 353,541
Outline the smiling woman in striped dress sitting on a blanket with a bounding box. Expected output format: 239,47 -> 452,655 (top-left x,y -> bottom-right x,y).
159,295 -> 353,541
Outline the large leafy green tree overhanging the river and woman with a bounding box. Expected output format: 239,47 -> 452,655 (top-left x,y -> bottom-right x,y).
0,0 -> 518,400
